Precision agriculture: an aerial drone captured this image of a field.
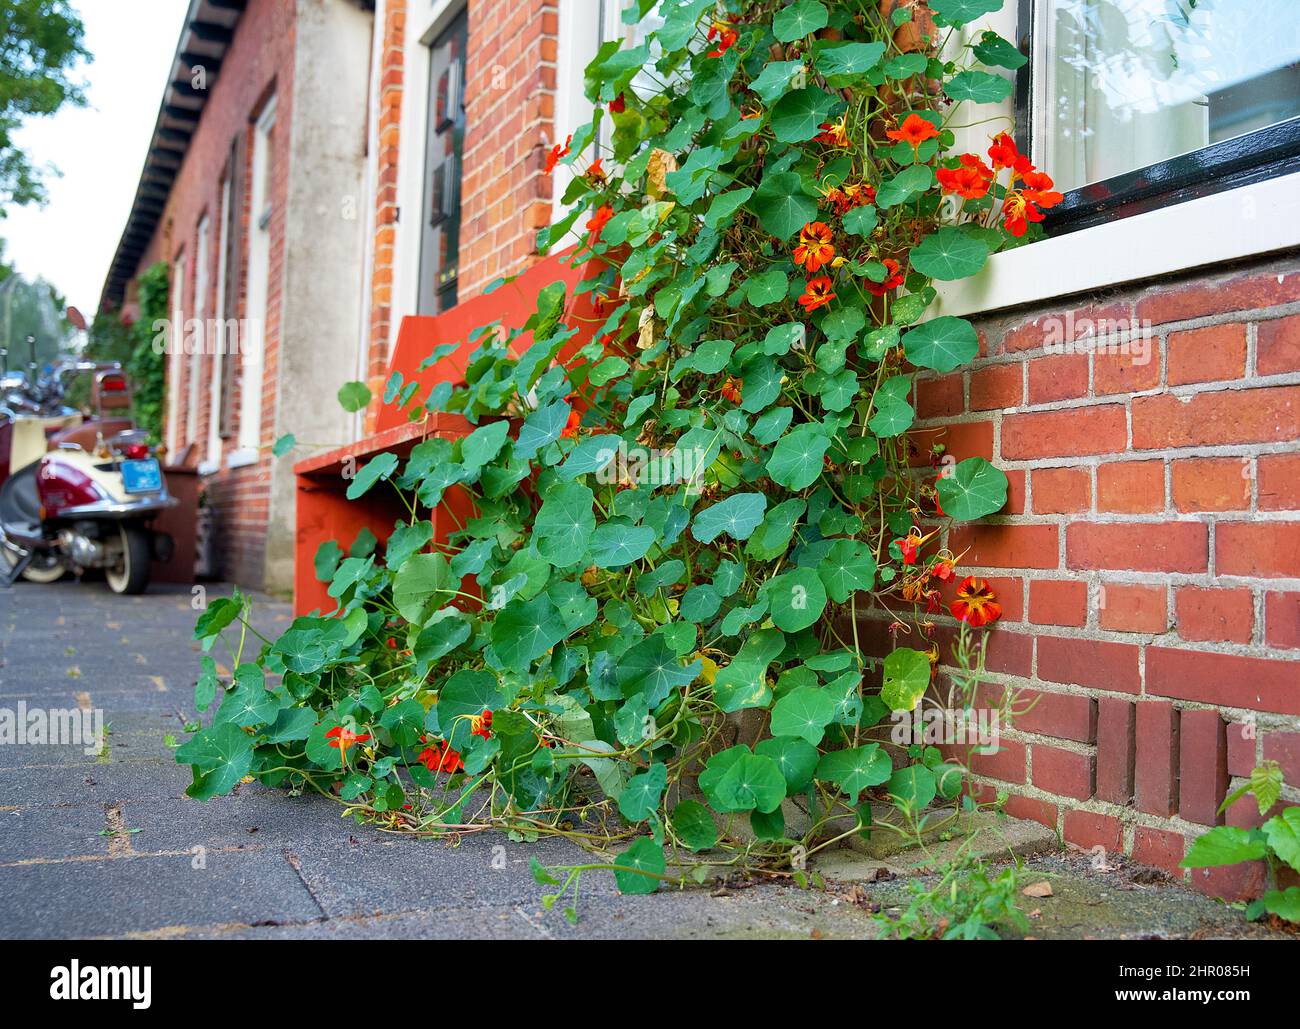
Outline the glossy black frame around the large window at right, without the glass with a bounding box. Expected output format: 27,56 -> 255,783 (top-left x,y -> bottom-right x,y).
1015,0 -> 1300,235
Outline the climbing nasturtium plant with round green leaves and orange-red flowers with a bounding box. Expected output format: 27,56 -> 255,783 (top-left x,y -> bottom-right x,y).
177,0 -> 1060,903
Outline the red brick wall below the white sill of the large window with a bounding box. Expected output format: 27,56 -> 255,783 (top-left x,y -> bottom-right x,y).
899,257 -> 1300,895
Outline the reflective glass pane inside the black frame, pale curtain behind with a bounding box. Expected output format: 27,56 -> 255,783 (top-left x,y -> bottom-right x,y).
1040,0 -> 1300,190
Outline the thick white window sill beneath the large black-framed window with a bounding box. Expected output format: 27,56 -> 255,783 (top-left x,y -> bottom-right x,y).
931,173 -> 1300,317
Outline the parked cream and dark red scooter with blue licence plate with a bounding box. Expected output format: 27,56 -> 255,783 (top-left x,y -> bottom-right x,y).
0,361 -> 177,594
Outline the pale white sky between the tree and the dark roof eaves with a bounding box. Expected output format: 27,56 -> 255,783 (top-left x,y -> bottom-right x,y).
0,0 -> 190,316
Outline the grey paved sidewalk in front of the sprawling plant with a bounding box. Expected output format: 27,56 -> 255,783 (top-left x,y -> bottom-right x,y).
0,581 -> 871,938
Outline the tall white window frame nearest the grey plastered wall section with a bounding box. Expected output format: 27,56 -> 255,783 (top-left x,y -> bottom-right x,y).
226,97 -> 276,468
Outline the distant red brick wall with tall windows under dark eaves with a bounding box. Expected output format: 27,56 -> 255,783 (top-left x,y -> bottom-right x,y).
139,0 -> 294,586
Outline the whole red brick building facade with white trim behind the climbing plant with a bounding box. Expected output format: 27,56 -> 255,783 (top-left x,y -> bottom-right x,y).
104,0 -> 1300,895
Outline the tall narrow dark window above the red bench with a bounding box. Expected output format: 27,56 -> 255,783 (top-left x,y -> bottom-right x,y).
416,9 -> 469,314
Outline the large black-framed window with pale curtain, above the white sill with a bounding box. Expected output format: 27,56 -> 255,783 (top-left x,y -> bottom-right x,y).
1018,0 -> 1300,231
